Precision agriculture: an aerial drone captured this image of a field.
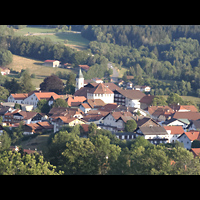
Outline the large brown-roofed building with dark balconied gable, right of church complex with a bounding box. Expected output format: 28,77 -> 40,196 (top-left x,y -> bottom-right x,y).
114,89 -> 145,108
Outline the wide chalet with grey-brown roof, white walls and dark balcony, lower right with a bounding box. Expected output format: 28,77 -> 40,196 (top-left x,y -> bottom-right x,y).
136,126 -> 169,145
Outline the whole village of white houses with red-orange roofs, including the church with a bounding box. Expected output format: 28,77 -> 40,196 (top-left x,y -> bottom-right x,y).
0,60 -> 200,159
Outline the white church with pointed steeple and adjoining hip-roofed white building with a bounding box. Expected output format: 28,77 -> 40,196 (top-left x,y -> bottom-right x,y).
74,68 -> 115,104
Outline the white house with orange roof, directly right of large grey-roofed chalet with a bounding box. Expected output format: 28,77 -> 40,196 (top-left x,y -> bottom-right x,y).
163,126 -> 184,143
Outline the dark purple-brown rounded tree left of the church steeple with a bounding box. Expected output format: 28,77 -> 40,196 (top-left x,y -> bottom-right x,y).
40,74 -> 63,94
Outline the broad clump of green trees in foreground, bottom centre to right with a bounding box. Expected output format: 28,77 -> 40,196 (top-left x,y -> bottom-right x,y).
44,125 -> 200,175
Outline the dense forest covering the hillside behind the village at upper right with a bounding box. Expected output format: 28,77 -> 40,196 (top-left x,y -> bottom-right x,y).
81,25 -> 200,96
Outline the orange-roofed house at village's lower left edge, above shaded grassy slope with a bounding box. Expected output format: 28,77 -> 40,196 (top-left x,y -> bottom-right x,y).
23,122 -> 53,135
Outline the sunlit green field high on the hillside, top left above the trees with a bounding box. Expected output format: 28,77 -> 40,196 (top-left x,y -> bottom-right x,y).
15,27 -> 90,50
